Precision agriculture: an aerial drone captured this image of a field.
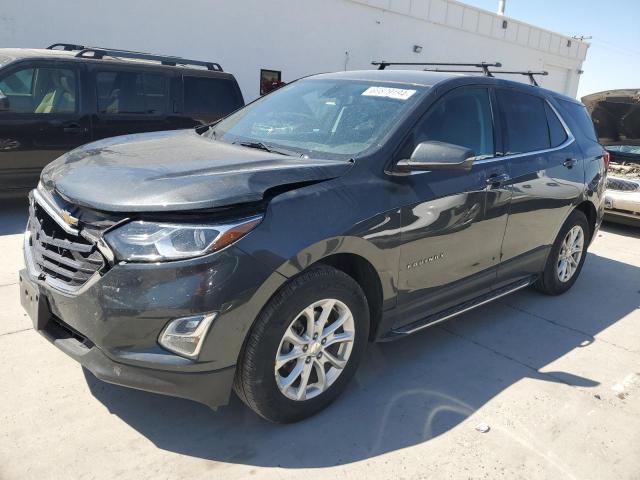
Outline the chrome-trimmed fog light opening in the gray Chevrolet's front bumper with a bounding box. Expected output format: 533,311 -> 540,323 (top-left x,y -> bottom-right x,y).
158,313 -> 216,359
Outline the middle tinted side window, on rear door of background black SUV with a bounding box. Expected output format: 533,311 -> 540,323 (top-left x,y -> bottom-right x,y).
96,72 -> 167,115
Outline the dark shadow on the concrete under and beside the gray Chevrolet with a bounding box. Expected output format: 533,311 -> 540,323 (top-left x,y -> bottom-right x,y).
85,244 -> 640,468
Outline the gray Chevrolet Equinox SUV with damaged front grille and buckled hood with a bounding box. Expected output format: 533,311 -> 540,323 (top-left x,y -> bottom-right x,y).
20,70 -> 607,422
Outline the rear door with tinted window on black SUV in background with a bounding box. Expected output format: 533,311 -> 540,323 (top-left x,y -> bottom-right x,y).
92,65 -> 176,139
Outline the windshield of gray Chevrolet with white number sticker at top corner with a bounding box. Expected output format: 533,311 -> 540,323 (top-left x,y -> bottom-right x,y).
207,79 -> 428,158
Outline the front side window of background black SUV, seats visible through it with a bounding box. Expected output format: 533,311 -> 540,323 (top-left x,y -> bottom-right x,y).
0,67 -> 77,114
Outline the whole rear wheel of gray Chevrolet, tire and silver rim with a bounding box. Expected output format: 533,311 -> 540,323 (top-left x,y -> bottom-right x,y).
534,210 -> 591,295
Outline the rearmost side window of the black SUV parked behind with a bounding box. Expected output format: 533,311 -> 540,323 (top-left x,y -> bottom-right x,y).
184,76 -> 242,116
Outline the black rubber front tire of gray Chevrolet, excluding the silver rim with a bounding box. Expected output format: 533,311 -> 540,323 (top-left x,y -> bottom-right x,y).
234,266 -> 370,423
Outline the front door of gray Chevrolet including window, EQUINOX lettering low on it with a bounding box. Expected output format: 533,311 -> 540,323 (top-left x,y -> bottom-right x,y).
396,87 -> 511,327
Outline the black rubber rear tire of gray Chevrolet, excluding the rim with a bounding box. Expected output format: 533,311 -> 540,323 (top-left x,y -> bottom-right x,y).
534,210 -> 591,295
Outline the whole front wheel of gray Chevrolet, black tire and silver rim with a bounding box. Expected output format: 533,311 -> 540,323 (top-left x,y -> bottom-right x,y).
234,266 -> 369,423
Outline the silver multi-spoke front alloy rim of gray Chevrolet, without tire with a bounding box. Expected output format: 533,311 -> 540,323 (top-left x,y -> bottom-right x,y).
275,299 -> 355,401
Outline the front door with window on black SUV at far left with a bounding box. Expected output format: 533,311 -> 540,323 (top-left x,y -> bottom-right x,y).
0,61 -> 91,191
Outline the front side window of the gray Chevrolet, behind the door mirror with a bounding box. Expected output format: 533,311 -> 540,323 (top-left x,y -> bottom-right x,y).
401,87 -> 495,158
